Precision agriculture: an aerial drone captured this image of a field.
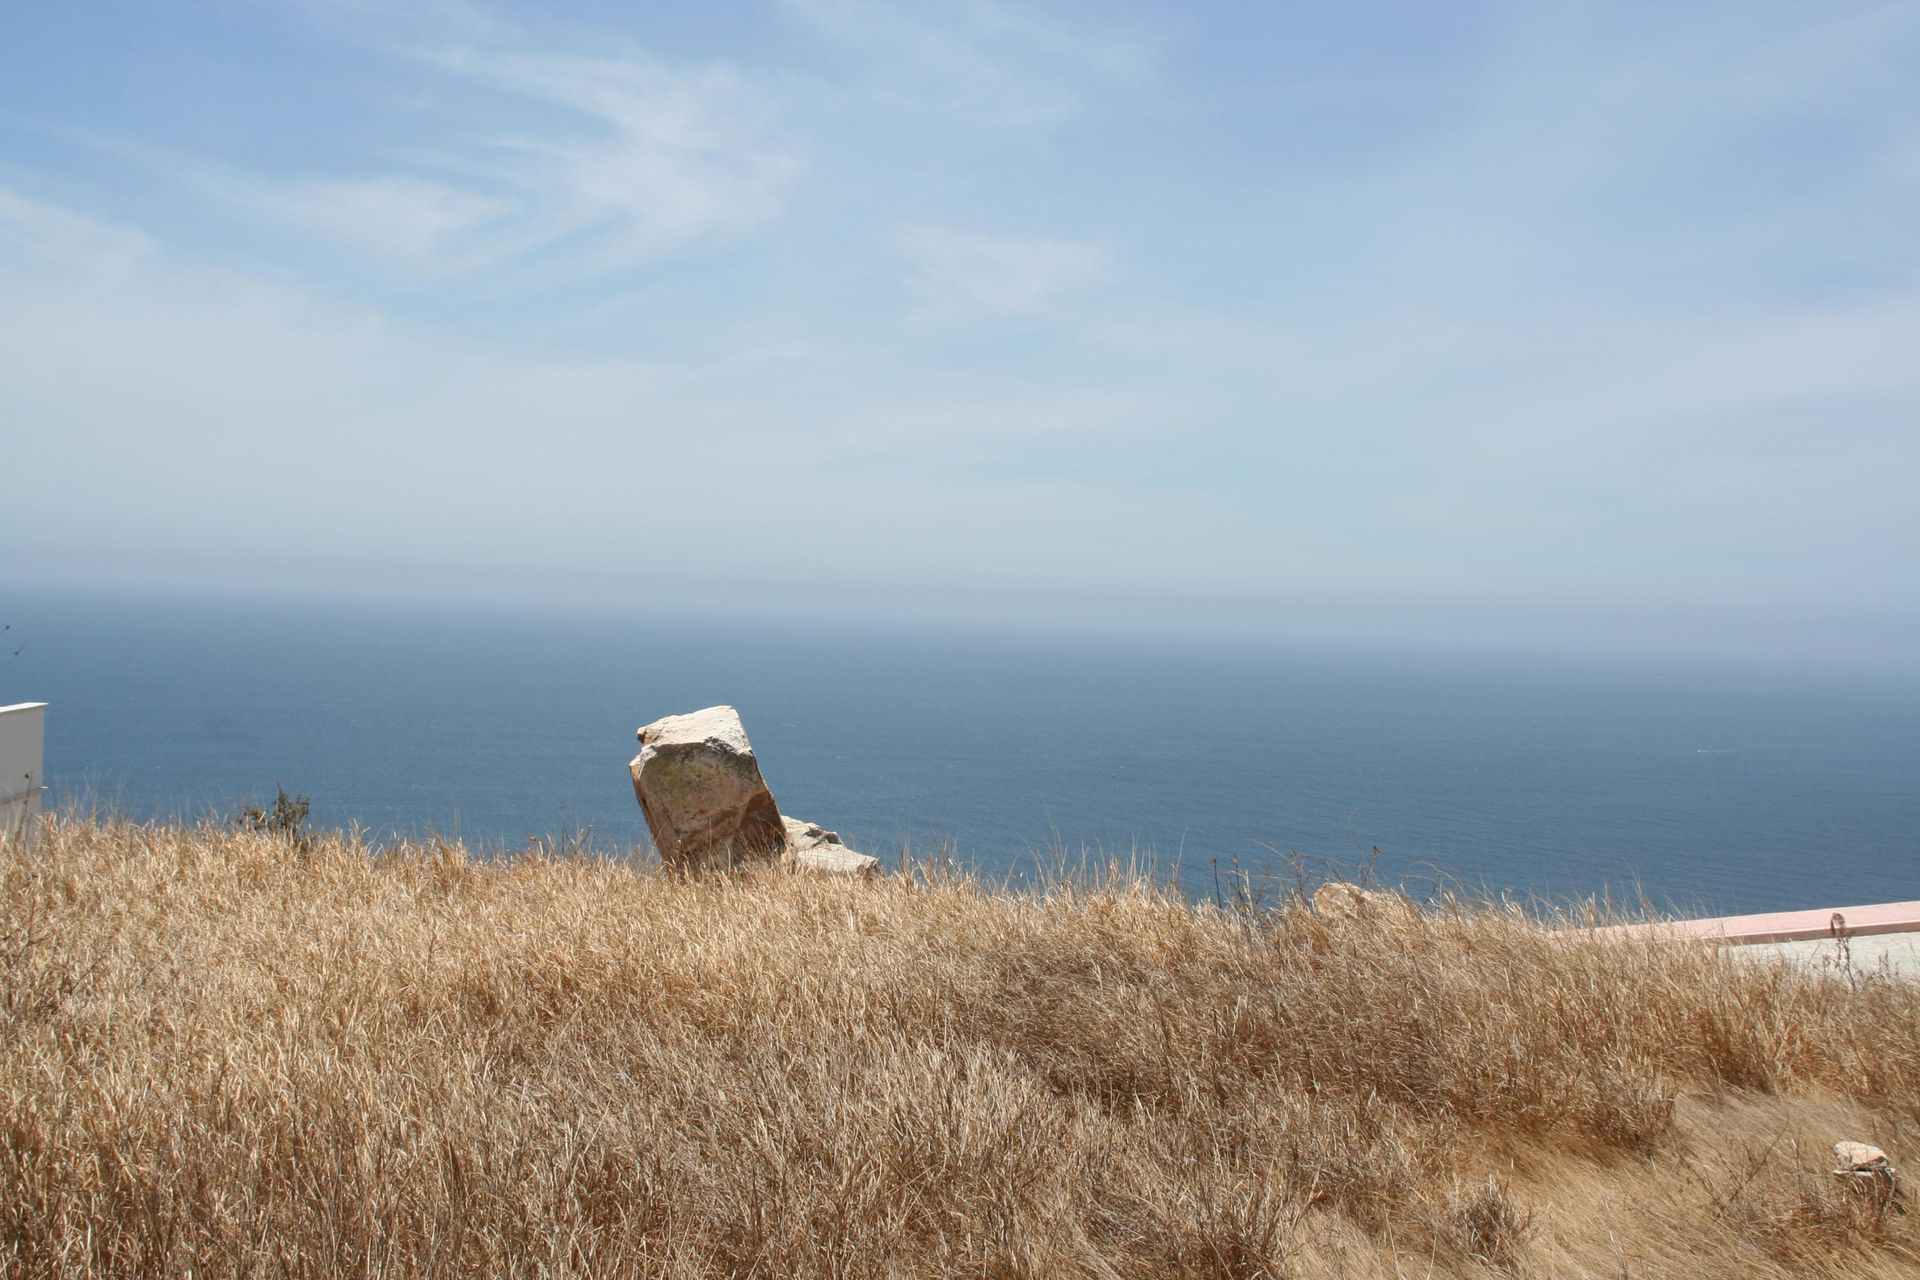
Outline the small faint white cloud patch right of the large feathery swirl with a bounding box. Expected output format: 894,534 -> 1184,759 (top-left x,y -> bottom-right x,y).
897,226 -> 1112,315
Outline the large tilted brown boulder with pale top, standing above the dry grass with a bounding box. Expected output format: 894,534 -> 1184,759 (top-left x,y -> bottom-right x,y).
628,706 -> 787,869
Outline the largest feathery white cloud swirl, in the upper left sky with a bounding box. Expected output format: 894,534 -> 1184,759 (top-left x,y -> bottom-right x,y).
133,0 -> 804,284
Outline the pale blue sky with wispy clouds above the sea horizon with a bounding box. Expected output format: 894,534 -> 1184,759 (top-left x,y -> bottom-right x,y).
0,0 -> 1920,660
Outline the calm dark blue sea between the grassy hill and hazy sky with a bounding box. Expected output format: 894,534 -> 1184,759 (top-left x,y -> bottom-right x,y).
0,593 -> 1920,912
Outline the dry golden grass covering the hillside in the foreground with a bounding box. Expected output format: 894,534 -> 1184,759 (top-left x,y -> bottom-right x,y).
0,818 -> 1920,1278
